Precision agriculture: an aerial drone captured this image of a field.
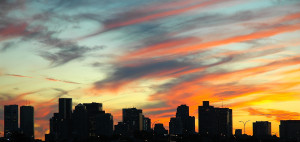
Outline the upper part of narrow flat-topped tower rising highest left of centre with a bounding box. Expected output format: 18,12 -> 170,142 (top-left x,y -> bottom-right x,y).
58,98 -> 72,119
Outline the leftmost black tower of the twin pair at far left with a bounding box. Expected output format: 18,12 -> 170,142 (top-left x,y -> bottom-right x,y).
4,105 -> 19,137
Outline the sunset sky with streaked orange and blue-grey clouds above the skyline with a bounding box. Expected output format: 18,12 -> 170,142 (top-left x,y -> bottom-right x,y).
0,0 -> 300,139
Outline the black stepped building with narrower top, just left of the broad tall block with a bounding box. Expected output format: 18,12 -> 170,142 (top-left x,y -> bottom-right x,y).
169,105 -> 195,135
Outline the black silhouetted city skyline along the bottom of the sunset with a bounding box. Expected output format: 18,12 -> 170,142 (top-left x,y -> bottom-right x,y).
4,98 -> 300,142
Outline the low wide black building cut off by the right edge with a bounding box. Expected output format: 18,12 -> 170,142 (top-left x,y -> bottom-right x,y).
279,120 -> 300,142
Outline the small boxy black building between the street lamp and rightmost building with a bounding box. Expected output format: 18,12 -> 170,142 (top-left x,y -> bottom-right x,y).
253,121 -> 271,138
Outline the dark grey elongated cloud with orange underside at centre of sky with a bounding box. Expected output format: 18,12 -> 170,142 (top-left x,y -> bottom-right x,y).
94,60 -> 189,90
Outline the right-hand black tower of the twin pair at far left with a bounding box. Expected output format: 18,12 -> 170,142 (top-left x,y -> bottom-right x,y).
20,106 -> 34,139
